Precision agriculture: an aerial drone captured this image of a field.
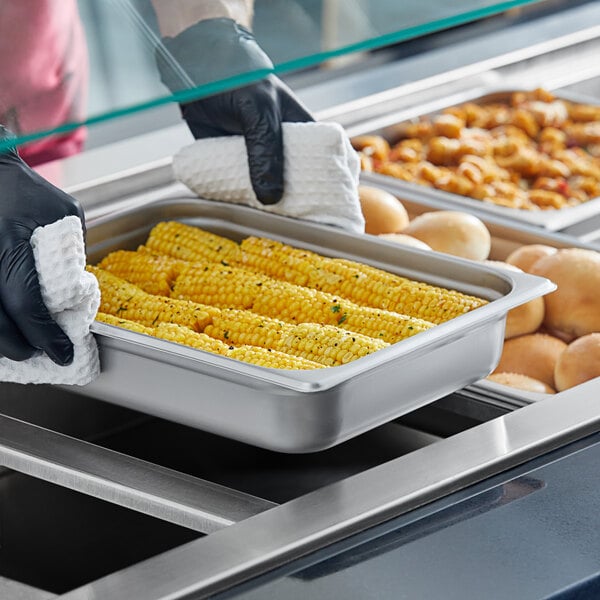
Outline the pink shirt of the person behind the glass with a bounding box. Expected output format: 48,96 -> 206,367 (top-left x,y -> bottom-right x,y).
0,0 -> 88,166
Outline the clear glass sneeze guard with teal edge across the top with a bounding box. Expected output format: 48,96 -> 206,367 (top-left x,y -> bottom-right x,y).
0,0 -> 544,150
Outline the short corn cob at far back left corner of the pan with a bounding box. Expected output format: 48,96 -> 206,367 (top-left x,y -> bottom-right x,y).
146,221 -> 241,264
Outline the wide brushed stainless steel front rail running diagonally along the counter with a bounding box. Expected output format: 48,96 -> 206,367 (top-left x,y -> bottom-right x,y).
59,384 -> 600,600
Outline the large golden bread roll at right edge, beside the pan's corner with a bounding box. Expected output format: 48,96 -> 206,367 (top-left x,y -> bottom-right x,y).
531,248 -> 600,337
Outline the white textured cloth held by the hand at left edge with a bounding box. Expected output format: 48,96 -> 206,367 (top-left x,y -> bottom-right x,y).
0,216 -> 100,385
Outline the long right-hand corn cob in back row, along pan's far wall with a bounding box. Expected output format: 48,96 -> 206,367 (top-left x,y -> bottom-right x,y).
241,237 -> 487,324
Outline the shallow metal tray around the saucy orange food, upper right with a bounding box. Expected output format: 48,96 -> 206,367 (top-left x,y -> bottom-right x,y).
351,88 -> 600,231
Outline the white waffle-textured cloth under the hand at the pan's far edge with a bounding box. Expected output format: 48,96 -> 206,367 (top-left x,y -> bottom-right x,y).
173,123 -> 365,233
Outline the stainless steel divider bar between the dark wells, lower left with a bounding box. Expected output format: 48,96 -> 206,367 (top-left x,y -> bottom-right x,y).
0,415 -> 275,533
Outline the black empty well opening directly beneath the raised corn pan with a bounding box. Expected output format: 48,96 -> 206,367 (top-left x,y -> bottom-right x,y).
94,418 -> 441,504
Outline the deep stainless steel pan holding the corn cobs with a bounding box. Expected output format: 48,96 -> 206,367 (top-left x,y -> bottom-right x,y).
81,199 -> 554,453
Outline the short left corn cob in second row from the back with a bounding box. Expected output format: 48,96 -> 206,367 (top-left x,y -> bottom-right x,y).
98,250 -> 185,296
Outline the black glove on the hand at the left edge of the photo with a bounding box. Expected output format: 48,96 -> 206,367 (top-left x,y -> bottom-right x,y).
0,126 -> 84,365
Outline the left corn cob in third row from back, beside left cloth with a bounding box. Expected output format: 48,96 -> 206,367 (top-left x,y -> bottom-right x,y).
87,266 -> 218,331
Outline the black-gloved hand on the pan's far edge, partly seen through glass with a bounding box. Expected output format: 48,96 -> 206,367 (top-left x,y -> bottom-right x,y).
157,18 -> 313,204
